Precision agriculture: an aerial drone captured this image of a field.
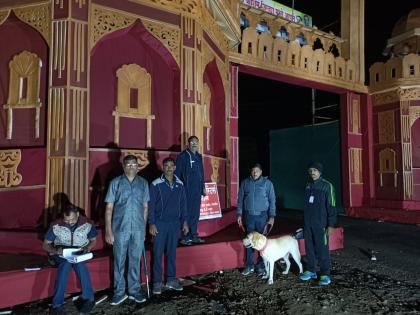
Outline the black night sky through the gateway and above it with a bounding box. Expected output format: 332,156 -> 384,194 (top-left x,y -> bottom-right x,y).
239,0 -> 420,178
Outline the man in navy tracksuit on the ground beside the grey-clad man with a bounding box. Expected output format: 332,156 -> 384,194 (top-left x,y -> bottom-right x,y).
149,157 -> 188,294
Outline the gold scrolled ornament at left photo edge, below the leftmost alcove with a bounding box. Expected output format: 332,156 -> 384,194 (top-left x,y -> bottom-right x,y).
0,150 -> 22,188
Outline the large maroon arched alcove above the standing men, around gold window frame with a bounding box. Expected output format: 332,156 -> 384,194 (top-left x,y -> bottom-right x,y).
90,20 -> 181,150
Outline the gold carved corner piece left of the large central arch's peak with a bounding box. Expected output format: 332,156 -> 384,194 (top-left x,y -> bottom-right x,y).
90,5 -> 136,48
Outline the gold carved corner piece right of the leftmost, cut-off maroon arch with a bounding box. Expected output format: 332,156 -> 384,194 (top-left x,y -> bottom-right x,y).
13,3 -> 51,46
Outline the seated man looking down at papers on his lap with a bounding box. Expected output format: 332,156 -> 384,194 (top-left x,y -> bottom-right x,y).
42,204 -> 98,314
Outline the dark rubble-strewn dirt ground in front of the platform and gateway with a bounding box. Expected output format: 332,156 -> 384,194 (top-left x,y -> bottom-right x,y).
13,211 -> 420,315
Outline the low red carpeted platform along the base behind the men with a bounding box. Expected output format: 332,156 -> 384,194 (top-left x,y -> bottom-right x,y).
0,219 -> 343,308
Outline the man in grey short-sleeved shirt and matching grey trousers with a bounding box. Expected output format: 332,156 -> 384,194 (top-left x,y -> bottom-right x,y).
105,155 -> 149,305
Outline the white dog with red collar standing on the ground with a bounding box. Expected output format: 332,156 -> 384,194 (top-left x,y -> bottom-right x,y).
242,232 -> 303,284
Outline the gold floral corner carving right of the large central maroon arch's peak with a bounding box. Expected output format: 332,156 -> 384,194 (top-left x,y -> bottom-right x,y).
143,21 -> 181,64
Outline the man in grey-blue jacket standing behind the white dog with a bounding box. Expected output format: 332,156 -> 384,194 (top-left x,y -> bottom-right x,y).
236,163 -> 276,276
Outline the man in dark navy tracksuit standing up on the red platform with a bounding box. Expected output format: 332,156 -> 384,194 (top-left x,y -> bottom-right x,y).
175,136 -> 206,245
